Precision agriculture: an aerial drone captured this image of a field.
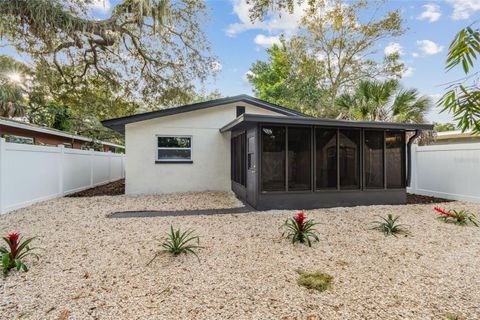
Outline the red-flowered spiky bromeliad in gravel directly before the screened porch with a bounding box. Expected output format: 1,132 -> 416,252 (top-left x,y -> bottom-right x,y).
283,212 -> 319,247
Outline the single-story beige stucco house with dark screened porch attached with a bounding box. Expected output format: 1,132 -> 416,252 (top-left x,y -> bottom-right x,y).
103,95 -> 433,209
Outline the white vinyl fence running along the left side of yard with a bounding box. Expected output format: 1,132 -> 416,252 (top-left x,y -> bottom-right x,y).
0,138 -> 125,214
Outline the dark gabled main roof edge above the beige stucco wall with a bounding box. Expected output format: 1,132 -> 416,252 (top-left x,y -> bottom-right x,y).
102,94 -> 310,133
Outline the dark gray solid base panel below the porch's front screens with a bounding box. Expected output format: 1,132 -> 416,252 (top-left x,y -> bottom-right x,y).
234,189 -> 407,210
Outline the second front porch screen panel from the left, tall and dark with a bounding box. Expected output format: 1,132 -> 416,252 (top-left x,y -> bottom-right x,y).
288,127 -> 312,191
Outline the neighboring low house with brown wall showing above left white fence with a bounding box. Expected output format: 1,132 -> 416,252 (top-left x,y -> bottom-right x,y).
0,117 -> 125,152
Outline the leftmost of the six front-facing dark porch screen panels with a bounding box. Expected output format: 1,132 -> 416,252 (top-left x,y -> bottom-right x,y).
261,126 -> 286,191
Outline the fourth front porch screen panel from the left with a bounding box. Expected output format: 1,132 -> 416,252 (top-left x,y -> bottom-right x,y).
339,130 -> 360,189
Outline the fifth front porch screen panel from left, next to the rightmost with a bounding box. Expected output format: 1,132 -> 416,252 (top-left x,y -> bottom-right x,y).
363,130 -> 384,189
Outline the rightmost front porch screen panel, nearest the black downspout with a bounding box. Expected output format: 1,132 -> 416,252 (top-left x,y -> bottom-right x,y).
385,131 -> 405,188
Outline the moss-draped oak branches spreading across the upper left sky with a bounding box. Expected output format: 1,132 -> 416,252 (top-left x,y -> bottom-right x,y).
0,0 -> 214,105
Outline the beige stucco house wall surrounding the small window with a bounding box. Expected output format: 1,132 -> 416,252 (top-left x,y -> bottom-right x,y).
125,103 -> 280,194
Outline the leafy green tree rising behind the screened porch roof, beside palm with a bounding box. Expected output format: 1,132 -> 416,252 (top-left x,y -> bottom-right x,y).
248,0 -> 404,117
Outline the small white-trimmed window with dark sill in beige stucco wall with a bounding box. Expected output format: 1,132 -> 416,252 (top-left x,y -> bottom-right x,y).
156,136 -> 192,162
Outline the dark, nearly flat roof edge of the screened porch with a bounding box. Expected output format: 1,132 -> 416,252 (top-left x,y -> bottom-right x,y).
220,113 -> 433,132
